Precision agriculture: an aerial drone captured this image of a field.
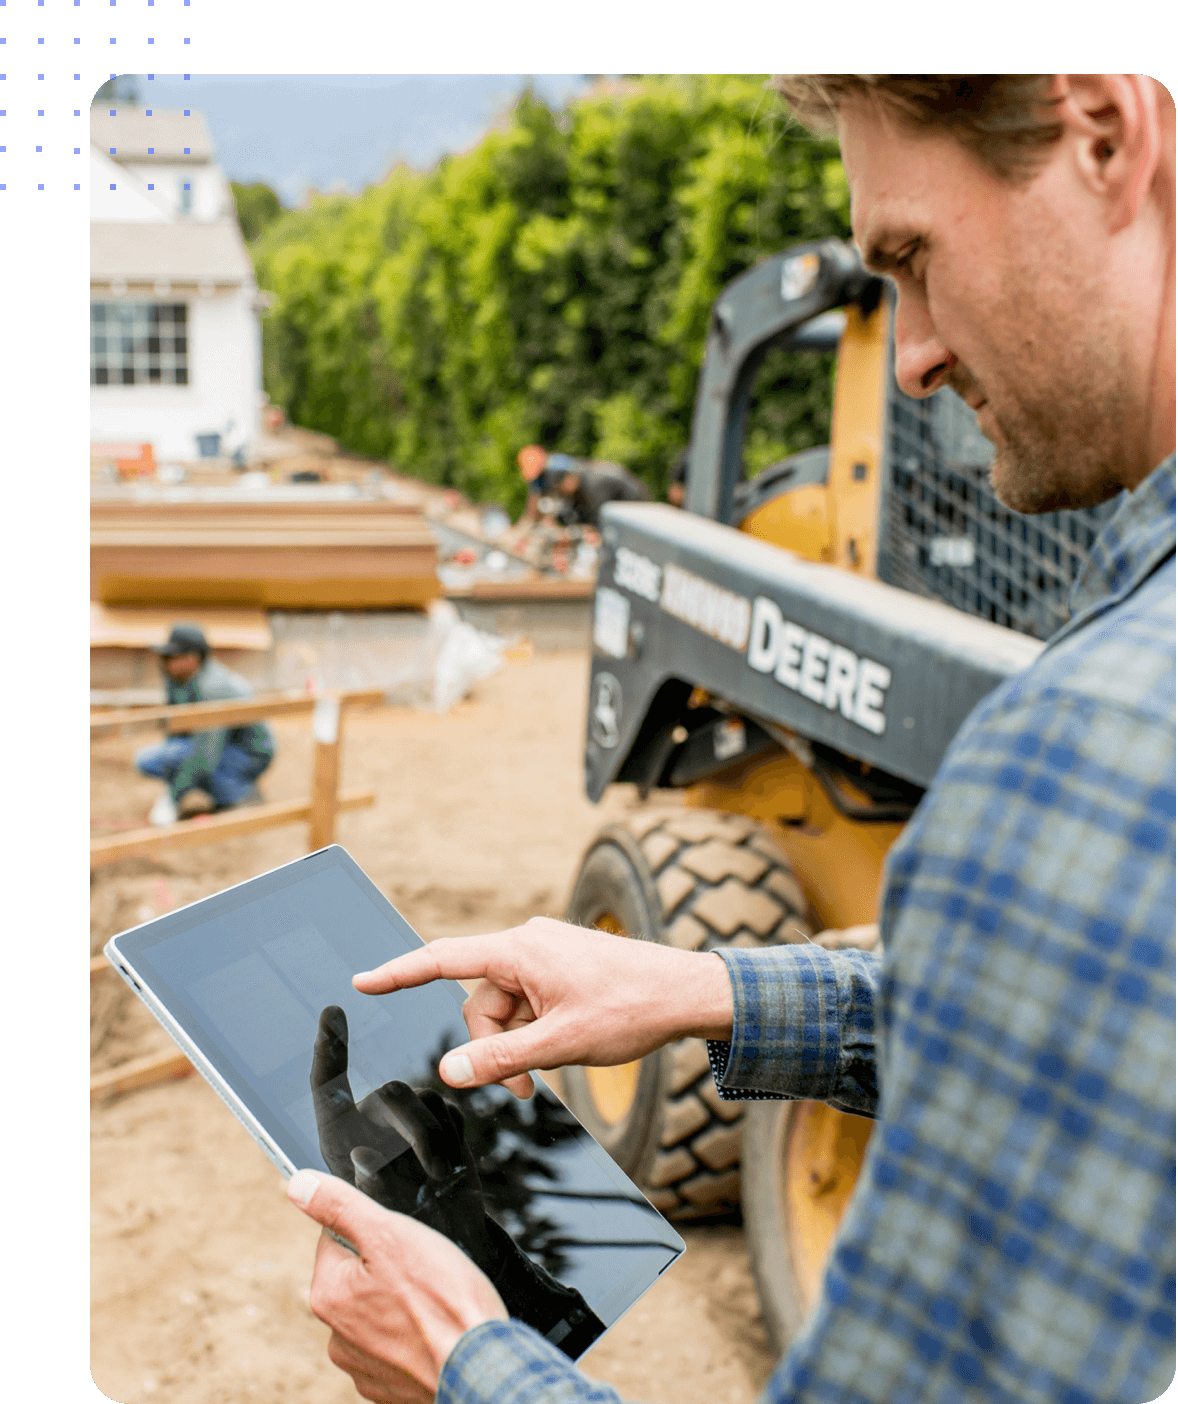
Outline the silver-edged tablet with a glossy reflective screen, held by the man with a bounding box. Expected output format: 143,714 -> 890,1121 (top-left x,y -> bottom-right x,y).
105,845 -> 685,1359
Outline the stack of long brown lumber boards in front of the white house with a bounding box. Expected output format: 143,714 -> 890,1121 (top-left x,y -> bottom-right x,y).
90,493 -> 441,609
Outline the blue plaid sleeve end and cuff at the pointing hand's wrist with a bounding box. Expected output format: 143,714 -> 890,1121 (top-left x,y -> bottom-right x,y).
708,943 -> 879,1115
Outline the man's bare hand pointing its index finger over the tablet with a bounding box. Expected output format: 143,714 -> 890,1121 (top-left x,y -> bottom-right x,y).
352,917 -> 733,1097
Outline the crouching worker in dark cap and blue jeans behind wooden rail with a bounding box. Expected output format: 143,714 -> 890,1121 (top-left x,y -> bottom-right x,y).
135,623 -> 275,824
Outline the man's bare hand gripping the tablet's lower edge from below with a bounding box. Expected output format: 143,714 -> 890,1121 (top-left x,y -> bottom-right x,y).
286,1170 -> 508,1404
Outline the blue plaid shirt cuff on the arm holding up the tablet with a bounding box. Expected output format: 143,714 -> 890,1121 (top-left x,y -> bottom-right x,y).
437,1321 -> 623,1404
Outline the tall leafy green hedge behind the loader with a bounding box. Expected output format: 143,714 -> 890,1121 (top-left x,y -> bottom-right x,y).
243,74 -> 849,511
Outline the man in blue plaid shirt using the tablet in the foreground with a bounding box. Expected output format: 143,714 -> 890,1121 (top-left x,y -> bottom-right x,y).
289,73 -> 1175,1404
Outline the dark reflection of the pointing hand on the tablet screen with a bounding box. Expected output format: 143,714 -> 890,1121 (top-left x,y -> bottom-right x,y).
310,1005 -> 501,1278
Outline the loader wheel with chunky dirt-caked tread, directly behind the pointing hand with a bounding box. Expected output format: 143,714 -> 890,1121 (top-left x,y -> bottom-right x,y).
562,810 -> 813,1220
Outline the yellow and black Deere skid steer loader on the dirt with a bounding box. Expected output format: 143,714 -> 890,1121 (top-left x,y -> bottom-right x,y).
562,240 -> 1116,1351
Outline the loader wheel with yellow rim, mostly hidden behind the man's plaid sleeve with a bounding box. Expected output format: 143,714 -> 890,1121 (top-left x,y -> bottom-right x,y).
740,927 -> 879,1355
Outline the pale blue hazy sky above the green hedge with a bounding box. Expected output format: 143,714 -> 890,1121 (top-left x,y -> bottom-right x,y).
108,73 -> 612,209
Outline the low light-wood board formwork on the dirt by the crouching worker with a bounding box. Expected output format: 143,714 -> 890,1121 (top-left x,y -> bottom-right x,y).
90,688 -> 383,1102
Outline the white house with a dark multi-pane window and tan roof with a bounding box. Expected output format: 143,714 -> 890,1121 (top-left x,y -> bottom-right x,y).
90,107 -> 268,462
